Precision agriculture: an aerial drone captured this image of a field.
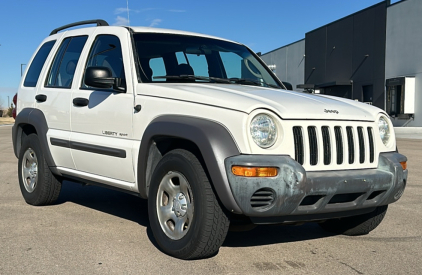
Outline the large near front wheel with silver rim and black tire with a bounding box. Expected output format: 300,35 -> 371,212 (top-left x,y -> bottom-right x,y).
148,149 -> 229,260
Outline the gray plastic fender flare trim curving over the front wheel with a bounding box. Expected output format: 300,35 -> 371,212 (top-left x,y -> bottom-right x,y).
138,115 -> 242,214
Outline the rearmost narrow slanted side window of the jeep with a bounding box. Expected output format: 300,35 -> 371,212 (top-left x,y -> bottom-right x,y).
23,40 -> 56,87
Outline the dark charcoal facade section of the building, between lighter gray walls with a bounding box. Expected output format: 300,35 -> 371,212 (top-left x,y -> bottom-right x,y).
298,1 -> 389,109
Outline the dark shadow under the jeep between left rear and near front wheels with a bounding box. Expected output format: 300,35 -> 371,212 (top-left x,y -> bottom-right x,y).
56,181 -> 149,227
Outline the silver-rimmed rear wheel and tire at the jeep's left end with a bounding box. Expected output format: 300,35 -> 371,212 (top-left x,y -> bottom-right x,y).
18,134 -> 62,206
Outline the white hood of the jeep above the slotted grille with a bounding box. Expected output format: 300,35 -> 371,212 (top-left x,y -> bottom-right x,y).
137,83 -> 382,121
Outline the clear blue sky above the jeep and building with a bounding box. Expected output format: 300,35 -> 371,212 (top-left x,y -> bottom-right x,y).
0,0 -> 397,107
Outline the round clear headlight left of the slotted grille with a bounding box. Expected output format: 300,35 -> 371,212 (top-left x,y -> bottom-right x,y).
250,114 -> 277,148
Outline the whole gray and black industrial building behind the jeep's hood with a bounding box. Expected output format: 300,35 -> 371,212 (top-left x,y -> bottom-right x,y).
261,0 -> 422,127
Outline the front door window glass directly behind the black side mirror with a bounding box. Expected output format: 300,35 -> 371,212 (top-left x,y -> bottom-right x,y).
82,35 -> 126,88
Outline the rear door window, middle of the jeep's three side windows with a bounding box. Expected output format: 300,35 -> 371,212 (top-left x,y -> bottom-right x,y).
45,36 -> 88,88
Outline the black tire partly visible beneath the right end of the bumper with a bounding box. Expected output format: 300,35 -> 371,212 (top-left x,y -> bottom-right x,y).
319,205 -> 388,236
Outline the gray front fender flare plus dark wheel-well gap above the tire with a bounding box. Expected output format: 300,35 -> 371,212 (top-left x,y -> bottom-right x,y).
137,115 -> 242,214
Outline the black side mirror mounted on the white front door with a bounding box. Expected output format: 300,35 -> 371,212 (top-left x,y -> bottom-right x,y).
84,67 -> 125,92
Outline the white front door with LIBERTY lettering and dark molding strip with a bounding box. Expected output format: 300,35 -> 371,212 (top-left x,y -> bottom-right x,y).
71,28 -> 135,190
